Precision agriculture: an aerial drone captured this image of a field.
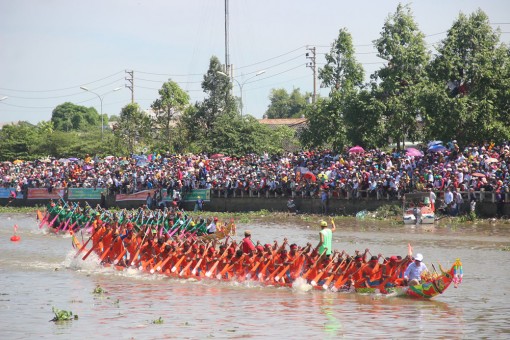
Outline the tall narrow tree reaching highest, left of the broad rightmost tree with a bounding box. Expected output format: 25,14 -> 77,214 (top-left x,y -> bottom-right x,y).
372,4 -> 429,148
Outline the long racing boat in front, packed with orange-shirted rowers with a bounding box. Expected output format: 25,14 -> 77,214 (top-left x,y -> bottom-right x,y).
71,228 -> 463,299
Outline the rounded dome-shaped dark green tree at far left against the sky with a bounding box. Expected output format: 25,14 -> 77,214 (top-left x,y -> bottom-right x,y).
51,102 -> 101,132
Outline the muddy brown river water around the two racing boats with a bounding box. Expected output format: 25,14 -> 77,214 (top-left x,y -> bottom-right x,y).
0,214 -> 510,339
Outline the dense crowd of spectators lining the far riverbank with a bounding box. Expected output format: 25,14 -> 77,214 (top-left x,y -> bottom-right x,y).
0,141 -> 510,206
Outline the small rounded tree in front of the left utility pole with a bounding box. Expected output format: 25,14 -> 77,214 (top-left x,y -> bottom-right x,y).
114,103 -> 151,154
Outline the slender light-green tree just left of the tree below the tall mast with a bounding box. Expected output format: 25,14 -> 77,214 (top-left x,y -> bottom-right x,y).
151,80 -> 189,146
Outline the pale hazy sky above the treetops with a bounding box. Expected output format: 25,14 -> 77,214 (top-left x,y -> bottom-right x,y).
0,0 -> 510,123
